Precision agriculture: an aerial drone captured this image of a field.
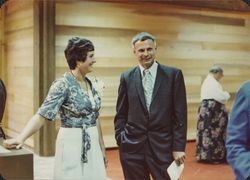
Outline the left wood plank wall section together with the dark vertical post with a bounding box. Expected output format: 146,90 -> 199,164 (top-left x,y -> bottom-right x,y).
1,0 -> 56,155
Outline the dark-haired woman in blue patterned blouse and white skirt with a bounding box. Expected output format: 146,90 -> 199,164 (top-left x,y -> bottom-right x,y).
4,37 -> 106,180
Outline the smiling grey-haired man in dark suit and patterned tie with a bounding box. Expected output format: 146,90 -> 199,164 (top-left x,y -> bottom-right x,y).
114,32 -> 187,180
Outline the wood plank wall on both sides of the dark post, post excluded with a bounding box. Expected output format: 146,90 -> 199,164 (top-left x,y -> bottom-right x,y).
0,0 -> 250,150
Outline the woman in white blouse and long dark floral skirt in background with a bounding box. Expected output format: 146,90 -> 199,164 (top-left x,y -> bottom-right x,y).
196,66 -> 230,163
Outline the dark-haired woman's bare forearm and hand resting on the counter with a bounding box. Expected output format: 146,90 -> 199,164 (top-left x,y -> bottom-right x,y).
3,114 -> 45,149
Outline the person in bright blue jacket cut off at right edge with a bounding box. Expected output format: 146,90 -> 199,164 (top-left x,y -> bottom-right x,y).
226,81 -> 250,180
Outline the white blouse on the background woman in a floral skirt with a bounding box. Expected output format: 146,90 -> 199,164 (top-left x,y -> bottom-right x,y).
201,74 -> 230,104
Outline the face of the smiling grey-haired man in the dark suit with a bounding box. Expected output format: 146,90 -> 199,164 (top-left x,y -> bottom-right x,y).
133,39 -> 156,69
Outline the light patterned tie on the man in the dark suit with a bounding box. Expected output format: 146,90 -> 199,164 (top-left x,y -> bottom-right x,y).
142,69 -> 153,110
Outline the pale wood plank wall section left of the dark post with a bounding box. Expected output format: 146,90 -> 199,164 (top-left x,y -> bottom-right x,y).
4,0 -> 34,146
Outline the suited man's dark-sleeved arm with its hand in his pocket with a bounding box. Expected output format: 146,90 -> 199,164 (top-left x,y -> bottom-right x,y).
114,75 -> 128,146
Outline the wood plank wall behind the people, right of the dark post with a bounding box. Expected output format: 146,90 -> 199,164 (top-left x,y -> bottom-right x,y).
56,1 -> 250,146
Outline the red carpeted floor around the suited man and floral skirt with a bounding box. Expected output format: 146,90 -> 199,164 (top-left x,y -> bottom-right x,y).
107,142 -> 235,180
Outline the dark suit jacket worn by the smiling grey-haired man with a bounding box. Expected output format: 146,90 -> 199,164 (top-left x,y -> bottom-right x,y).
114,63 -> 187,162
